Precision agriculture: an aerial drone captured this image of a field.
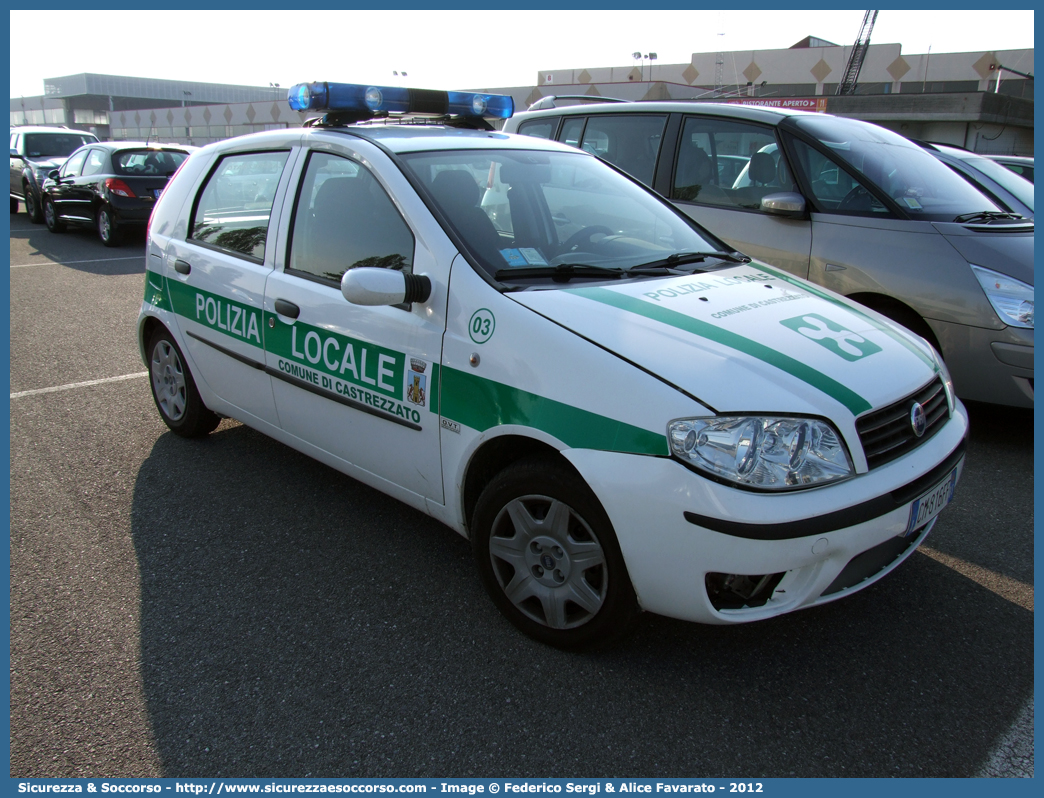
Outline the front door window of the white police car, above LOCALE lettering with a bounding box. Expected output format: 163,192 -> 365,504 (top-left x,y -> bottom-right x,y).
288,152 -> 413,283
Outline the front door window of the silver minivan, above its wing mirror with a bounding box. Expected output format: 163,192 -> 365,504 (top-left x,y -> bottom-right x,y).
670,117 -> 797,210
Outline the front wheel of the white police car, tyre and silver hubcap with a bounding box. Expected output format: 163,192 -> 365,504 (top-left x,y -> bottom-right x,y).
472,456 -> 640,651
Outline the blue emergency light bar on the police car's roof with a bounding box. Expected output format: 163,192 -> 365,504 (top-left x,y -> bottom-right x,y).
287,83 -> 515,119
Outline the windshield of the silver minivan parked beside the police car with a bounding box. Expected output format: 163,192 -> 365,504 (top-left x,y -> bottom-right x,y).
793,115 -> 1001,221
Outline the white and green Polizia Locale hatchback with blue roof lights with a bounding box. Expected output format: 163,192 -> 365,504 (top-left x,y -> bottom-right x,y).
138,84 -> 968,648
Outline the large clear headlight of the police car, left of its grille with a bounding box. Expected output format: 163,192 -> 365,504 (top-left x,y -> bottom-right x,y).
667,416 -> 855,491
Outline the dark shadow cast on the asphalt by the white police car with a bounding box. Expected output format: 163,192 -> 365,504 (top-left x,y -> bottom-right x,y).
132,422 -> 1034,777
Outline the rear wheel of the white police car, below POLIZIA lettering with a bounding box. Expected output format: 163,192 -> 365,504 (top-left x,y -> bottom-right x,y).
148,328 -> 221,438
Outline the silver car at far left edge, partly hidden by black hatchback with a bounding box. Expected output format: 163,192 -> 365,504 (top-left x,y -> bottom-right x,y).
10,126 -> 98,225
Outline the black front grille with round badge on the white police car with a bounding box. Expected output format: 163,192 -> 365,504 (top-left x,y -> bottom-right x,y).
855,376 -> 950,469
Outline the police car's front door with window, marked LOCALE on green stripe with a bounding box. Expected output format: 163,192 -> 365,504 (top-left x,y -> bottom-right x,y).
265,150 -> 446,503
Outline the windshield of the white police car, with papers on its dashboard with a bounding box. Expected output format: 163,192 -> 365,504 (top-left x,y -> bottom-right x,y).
402,149 -> 730,279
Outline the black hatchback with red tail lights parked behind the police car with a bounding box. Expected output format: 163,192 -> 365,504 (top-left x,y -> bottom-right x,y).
43,141 -> 194,247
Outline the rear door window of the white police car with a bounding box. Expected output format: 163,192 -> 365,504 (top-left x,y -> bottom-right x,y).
189,151 -> 289,262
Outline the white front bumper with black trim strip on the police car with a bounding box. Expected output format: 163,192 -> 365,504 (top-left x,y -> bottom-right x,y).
564,403 -> 968,624
